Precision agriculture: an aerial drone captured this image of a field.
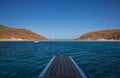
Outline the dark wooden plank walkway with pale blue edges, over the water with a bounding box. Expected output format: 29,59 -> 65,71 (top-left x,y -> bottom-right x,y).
39,56 -> 87,78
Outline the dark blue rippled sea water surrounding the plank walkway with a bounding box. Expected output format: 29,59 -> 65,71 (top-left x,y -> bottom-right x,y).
0,42 -> 120,78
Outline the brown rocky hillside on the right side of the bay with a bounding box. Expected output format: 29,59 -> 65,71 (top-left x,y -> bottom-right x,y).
77,29 -> 120,40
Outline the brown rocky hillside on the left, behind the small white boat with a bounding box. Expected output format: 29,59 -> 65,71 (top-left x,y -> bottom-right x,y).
0,25 -> 46,40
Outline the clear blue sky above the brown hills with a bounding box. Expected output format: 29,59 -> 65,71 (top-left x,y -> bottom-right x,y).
0,0 -> 120,39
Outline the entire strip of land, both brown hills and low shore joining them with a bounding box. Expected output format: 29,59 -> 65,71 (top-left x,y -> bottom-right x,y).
0,25 -> 120,41
